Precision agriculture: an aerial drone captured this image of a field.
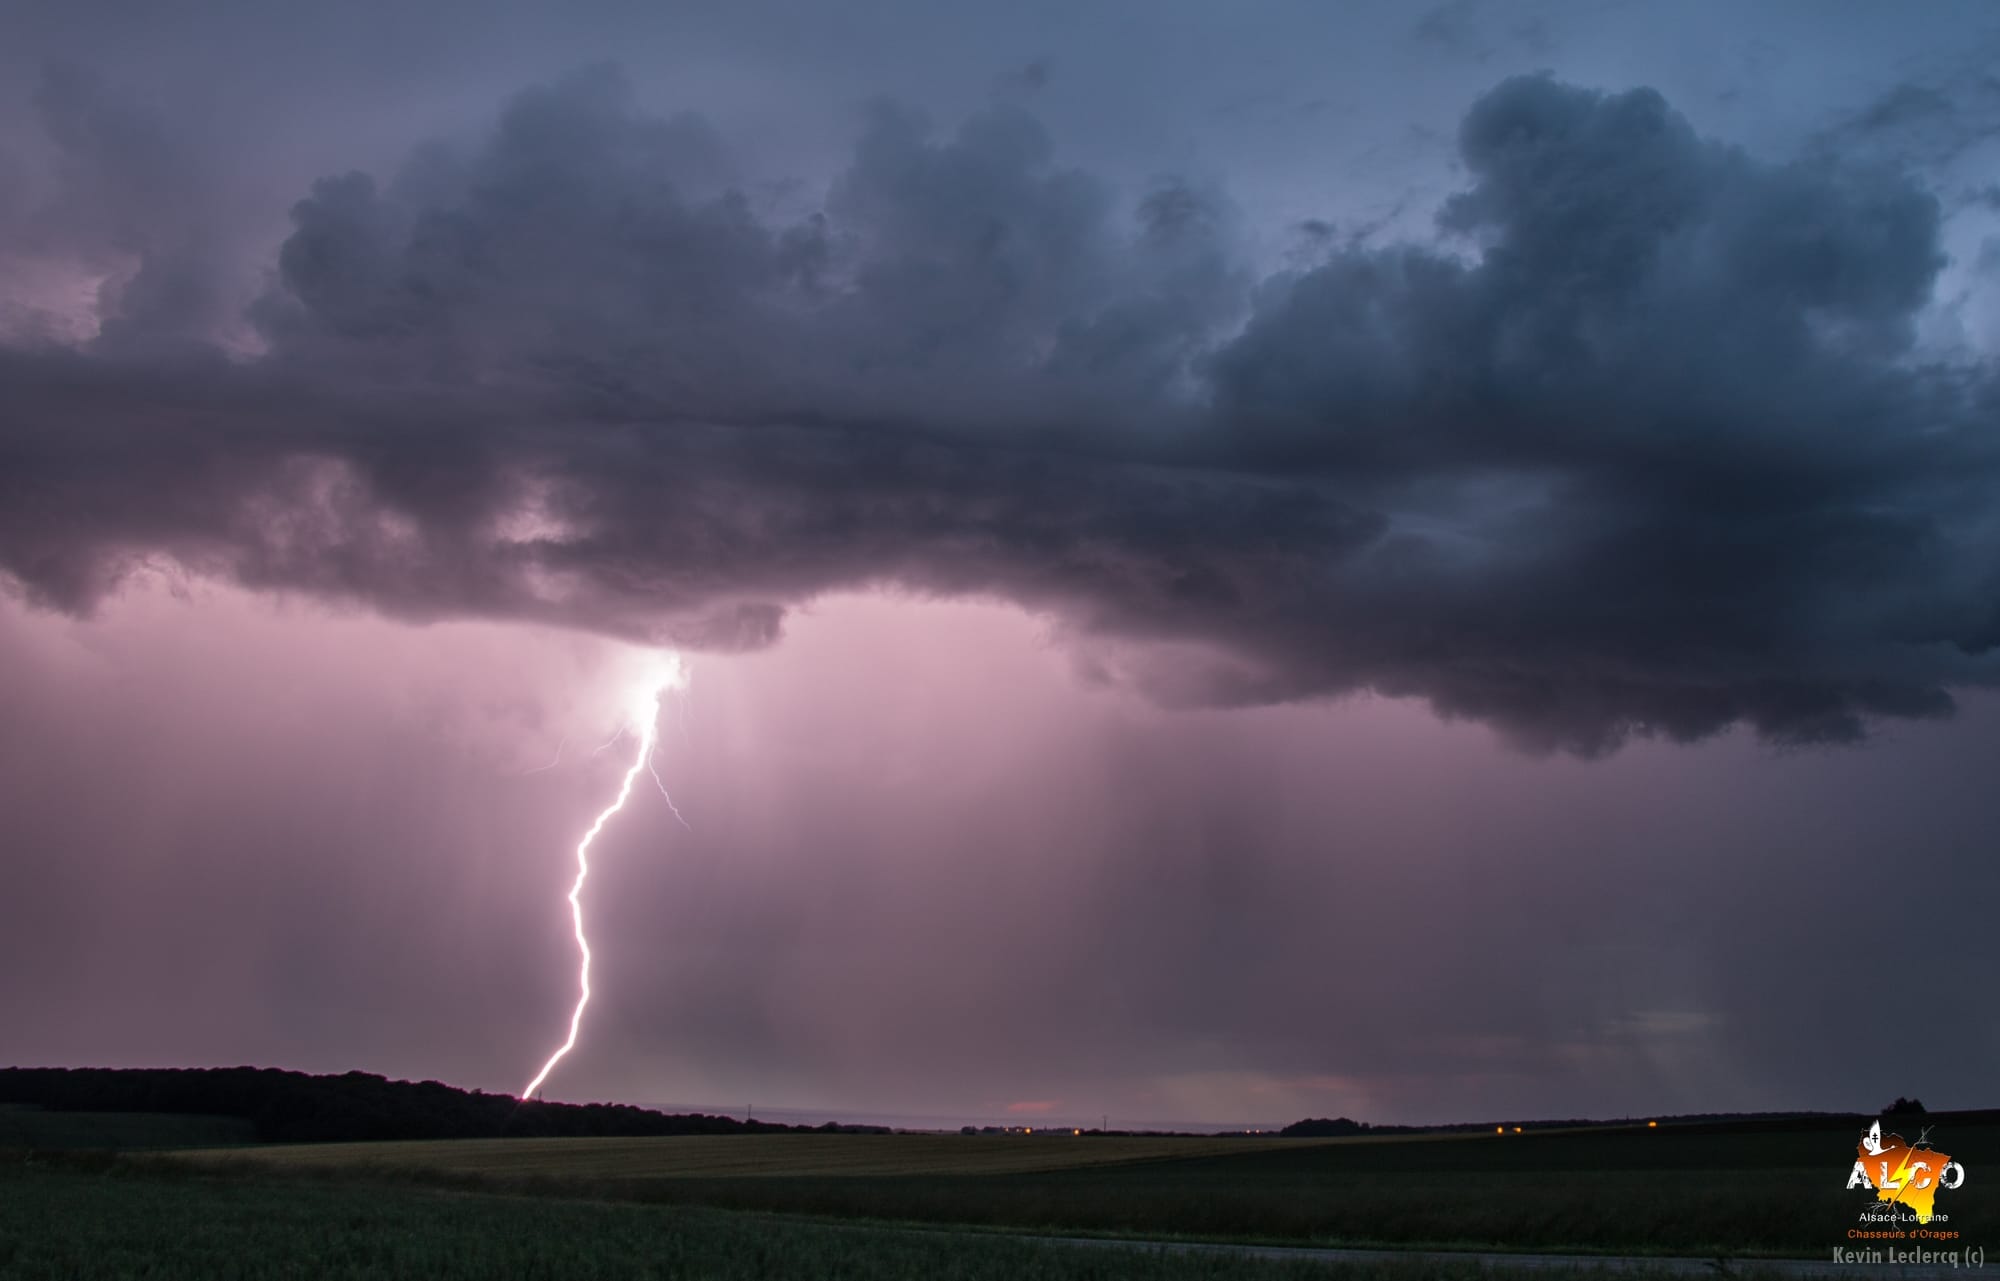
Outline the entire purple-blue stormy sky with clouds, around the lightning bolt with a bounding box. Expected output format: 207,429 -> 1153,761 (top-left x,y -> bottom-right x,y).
0,0 -> 2000,1127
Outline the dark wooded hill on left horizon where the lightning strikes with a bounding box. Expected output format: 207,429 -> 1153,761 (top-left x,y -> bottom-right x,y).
0,1067 -> 888,1143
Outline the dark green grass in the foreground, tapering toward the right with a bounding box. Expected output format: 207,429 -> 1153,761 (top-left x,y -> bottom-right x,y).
0,1155 -> 1752,1281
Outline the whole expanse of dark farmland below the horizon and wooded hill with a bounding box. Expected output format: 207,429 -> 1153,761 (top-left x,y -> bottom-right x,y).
0,1109 -> 2000,1279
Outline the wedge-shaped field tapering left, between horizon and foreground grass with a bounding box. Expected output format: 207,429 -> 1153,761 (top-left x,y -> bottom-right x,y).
176,1117 -> 2000,1257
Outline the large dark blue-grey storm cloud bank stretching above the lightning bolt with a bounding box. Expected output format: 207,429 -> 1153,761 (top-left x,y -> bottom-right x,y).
0,70 -> 2000,753
